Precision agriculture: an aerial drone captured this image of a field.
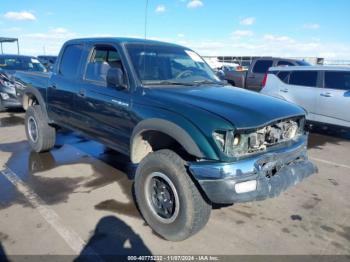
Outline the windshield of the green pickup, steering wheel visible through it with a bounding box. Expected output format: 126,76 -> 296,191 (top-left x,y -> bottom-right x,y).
127,44 -> 220,85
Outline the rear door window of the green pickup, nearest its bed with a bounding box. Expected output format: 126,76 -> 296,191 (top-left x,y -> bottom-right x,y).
59,45 -> 83,78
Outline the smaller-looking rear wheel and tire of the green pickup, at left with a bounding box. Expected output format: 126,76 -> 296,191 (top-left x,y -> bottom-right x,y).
25,105 -> 56,153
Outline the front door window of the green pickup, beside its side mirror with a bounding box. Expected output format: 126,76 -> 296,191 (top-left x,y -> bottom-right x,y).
85,46 -> 123,83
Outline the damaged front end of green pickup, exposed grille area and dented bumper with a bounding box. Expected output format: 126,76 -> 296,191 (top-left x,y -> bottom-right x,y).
189,118 -> 317,203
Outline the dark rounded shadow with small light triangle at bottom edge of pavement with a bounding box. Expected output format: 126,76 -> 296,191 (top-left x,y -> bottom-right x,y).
75,216 -> 152,262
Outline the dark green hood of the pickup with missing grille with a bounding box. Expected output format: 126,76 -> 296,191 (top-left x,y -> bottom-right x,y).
149,86 -> 305,129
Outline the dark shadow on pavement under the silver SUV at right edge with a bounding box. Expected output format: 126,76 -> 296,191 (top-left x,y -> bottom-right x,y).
308,124 -> 350,149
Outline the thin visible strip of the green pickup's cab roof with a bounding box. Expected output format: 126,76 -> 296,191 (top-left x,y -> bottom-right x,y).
66,37 -> 187,47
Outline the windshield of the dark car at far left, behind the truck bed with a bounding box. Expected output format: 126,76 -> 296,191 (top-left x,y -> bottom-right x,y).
0,57 -> 46,72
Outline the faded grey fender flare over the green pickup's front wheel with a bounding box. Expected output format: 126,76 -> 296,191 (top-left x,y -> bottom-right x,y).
130,118 -> 204,163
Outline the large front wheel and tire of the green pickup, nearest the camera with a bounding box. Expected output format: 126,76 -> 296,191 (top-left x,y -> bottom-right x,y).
135,150 -> 211,241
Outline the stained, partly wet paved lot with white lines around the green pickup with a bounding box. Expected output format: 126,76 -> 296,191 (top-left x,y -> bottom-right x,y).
0,109 -> 350,255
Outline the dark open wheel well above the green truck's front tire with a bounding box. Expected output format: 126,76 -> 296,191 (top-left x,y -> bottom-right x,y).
131,130 -> 195,164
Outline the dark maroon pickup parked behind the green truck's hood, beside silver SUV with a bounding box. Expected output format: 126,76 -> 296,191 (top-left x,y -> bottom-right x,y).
225,57 -> 310,91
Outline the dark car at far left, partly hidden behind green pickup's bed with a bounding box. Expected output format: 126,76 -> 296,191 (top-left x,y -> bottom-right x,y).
0,55 -> 47,111
